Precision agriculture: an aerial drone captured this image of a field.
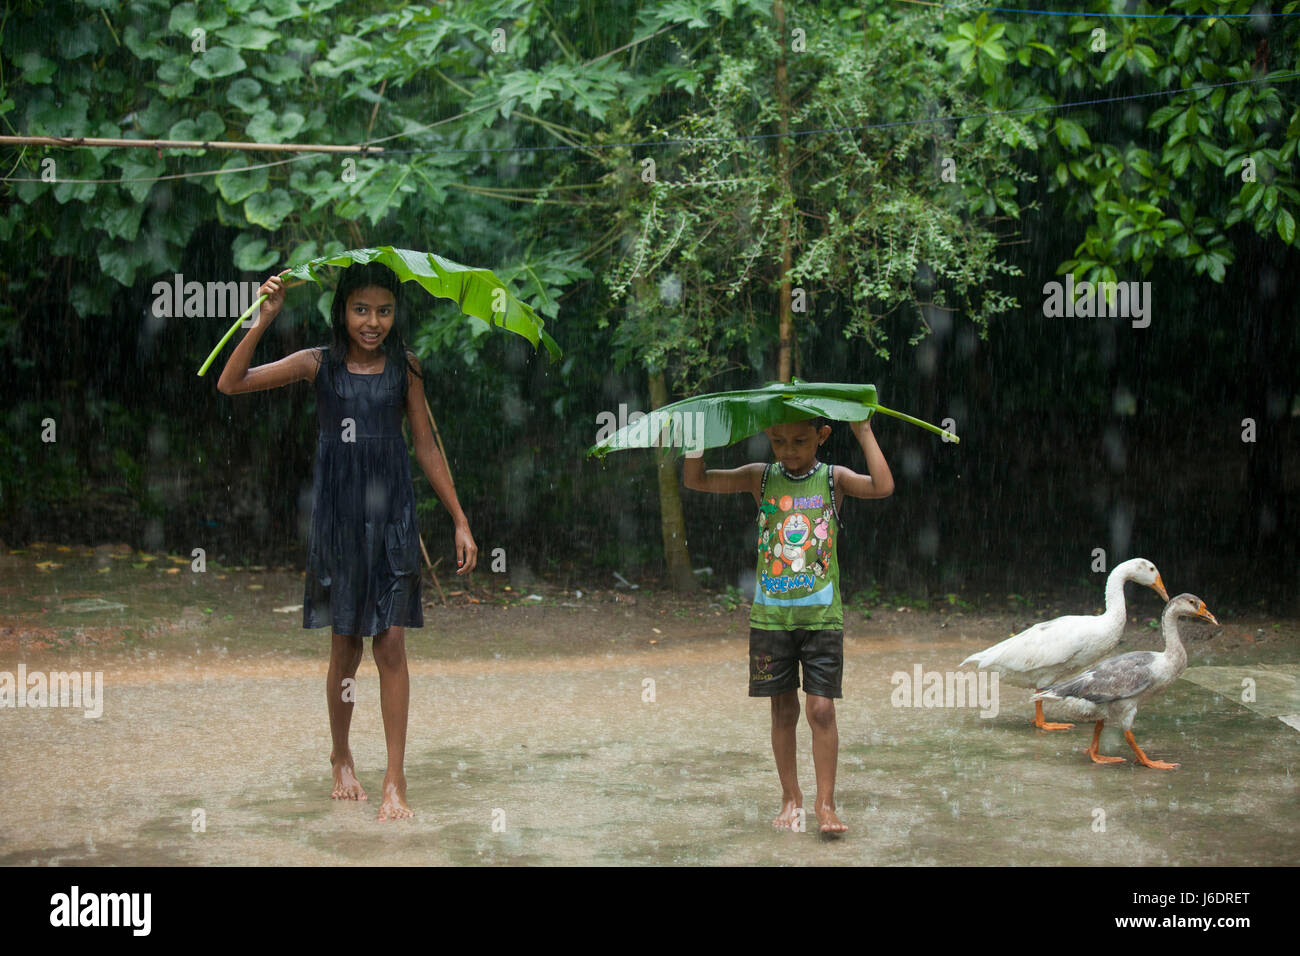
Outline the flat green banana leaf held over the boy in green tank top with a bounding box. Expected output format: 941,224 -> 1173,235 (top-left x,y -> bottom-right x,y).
586,381 -> 959,458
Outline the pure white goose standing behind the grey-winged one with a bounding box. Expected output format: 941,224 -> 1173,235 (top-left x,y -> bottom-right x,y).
962,558 -> 1169,730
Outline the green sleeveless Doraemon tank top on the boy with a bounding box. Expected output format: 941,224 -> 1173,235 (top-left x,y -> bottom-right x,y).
749,462 -> 844,631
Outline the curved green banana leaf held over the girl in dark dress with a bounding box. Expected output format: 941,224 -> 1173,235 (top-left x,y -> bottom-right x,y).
199,246 -> 560,375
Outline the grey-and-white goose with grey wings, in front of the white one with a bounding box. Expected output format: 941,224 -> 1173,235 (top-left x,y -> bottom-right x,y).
1034,594 -> 1218,770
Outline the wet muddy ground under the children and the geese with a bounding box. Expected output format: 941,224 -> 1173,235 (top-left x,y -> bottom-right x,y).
0,554 -> 1300,866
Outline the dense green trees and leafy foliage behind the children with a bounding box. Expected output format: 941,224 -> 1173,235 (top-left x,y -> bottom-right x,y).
0,0 -> 1300,606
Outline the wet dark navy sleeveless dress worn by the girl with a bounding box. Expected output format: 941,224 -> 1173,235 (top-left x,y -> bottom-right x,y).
303,350 -> 424,636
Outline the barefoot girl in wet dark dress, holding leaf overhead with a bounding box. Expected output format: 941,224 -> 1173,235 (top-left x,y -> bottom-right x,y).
217,264 -> 478,819
